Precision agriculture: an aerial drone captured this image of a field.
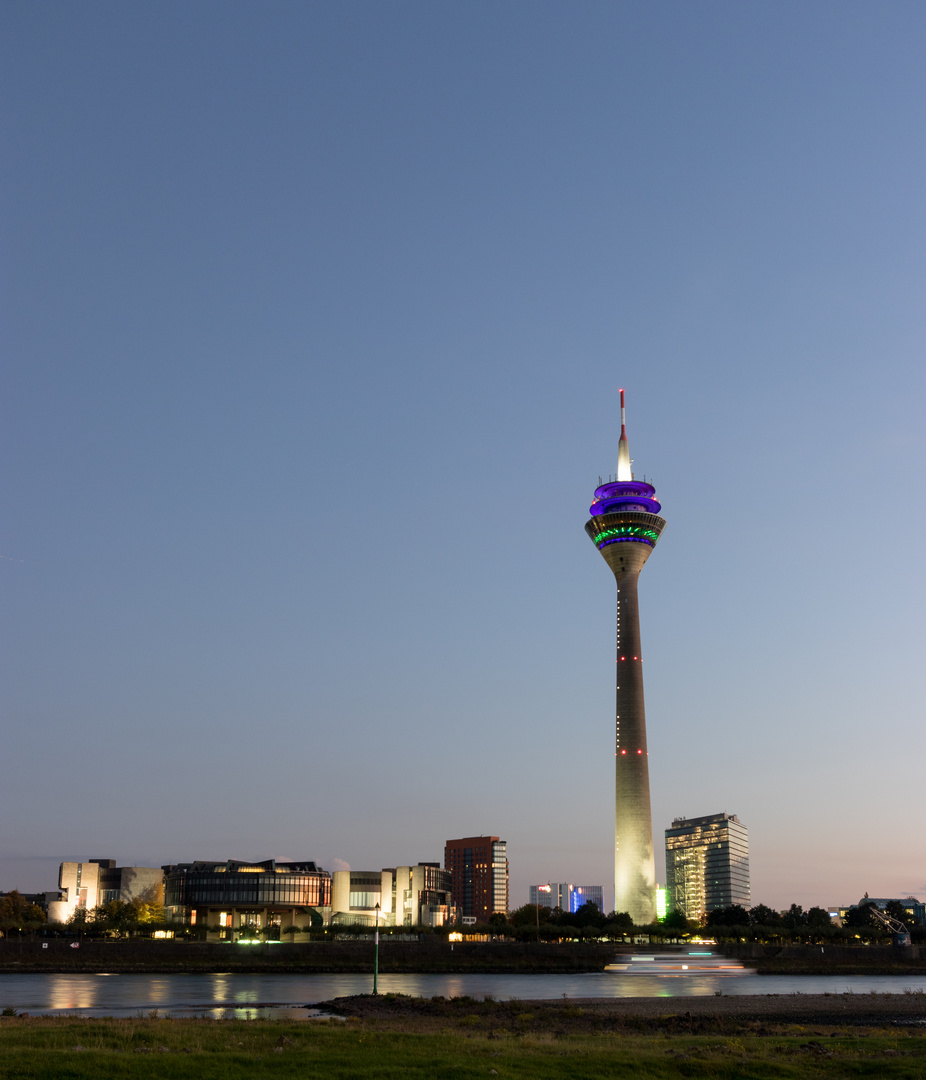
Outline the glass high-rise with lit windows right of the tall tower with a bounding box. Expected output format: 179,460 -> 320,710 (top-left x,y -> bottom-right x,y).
666,813 -> 749,922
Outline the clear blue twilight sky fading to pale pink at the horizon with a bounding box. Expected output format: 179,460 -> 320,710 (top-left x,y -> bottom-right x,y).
0,0 -> 926,906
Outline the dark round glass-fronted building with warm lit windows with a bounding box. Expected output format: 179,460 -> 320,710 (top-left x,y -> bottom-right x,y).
163,859 -> 331,941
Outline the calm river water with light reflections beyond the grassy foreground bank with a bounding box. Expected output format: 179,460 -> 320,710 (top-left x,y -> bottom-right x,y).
0,972 -> 926,1018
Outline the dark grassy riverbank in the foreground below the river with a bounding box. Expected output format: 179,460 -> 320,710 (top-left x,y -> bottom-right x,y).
0,996 -> 926,1080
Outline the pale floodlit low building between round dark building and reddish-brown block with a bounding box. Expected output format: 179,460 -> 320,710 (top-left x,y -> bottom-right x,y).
331,863 -> 454,927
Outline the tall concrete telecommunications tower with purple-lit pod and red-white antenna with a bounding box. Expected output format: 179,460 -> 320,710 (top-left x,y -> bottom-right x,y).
586,390 -> 666,926
